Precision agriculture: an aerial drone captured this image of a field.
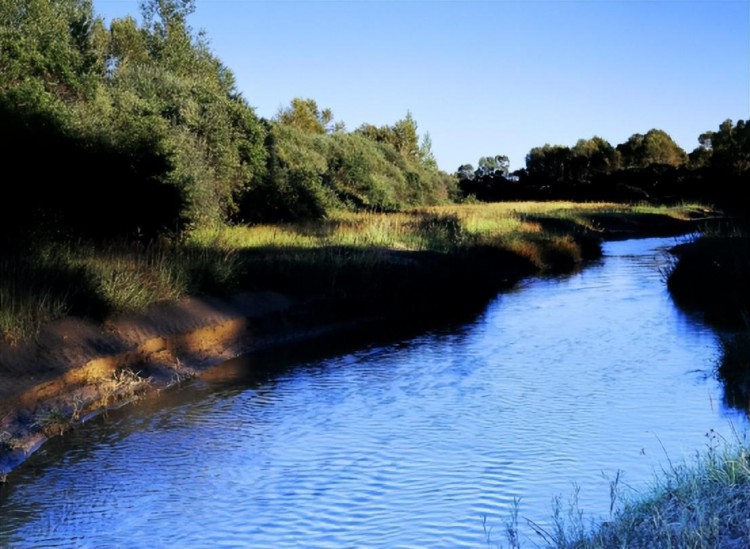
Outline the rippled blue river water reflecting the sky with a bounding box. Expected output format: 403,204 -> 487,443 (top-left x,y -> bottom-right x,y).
0,239 -> 745,547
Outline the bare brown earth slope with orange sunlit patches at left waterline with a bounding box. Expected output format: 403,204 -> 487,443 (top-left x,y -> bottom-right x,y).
0,292 -> 368,474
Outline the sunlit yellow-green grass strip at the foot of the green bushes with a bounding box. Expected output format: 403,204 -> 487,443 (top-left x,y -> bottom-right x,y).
189,202 -> 705,250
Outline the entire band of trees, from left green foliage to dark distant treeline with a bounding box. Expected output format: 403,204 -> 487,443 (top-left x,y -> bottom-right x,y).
0,0 -> 750,246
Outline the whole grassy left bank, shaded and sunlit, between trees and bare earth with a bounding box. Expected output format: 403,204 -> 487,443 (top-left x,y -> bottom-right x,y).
0,202 -> 705,343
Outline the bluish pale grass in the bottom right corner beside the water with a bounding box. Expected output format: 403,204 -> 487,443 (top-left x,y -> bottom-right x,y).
494,431 -> 750,549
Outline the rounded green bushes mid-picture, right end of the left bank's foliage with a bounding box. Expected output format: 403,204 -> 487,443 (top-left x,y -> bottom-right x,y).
241,98 -> 456,221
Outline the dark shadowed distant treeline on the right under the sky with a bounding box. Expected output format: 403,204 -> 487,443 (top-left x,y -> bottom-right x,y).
457,120 -> 750,214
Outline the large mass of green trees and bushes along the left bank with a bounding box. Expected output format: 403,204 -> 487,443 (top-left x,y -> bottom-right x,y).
0,0 -> 454,241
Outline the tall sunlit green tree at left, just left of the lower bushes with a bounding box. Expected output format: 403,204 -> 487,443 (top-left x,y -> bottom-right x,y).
102,0 -> 265,224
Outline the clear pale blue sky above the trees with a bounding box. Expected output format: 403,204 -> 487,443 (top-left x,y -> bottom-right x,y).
94,0 -> 750,172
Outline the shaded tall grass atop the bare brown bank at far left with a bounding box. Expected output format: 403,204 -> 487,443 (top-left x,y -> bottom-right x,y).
0,242 -> 239,343
